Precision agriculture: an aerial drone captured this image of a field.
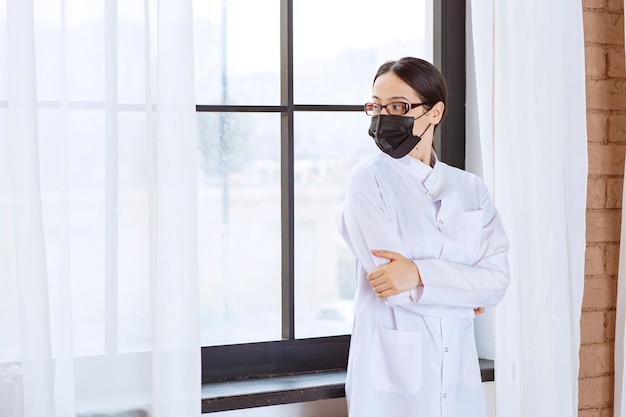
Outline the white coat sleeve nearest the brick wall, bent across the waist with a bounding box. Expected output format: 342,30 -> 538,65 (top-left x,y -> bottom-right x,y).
414,186 -> 510,308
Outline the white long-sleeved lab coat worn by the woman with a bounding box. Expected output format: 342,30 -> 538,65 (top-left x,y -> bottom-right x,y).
339,153 -> 510,417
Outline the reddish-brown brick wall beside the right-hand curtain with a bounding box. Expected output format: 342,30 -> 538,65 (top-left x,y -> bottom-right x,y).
578,0 -> 626,417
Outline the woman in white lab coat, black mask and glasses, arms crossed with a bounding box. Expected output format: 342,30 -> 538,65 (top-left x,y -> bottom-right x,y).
339,57 -> 509,417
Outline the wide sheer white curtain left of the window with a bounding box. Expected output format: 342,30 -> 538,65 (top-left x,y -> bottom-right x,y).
0,0 -> 200,417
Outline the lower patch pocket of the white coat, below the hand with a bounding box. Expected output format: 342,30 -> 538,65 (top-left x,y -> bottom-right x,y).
371,327 -> 422,395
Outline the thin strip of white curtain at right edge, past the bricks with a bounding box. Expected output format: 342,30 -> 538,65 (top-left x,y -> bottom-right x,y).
613,1 -> 626,417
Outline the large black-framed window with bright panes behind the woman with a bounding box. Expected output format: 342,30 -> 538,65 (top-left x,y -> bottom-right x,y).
194,0 -> 465,396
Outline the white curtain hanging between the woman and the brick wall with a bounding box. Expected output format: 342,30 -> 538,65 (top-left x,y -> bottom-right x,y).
467,0 -> 587,417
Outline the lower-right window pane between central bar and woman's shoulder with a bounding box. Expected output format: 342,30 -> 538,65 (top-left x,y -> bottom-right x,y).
294,112 -> 379,338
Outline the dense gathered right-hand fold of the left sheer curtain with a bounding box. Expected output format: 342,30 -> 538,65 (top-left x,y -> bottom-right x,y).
149,0 -> 201,417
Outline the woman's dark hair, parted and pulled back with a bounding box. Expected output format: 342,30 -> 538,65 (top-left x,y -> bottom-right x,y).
374,56 -> 448,120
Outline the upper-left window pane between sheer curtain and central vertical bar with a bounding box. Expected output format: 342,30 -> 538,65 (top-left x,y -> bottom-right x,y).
193,0 -> 280,105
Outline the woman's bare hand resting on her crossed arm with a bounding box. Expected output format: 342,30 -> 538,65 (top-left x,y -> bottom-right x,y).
367,250 -> 422,298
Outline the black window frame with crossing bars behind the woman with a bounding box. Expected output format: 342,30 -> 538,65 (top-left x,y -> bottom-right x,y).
196,0 -> 466,390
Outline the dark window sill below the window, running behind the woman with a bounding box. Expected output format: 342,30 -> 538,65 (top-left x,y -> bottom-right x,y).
202,359 -> 494,414
